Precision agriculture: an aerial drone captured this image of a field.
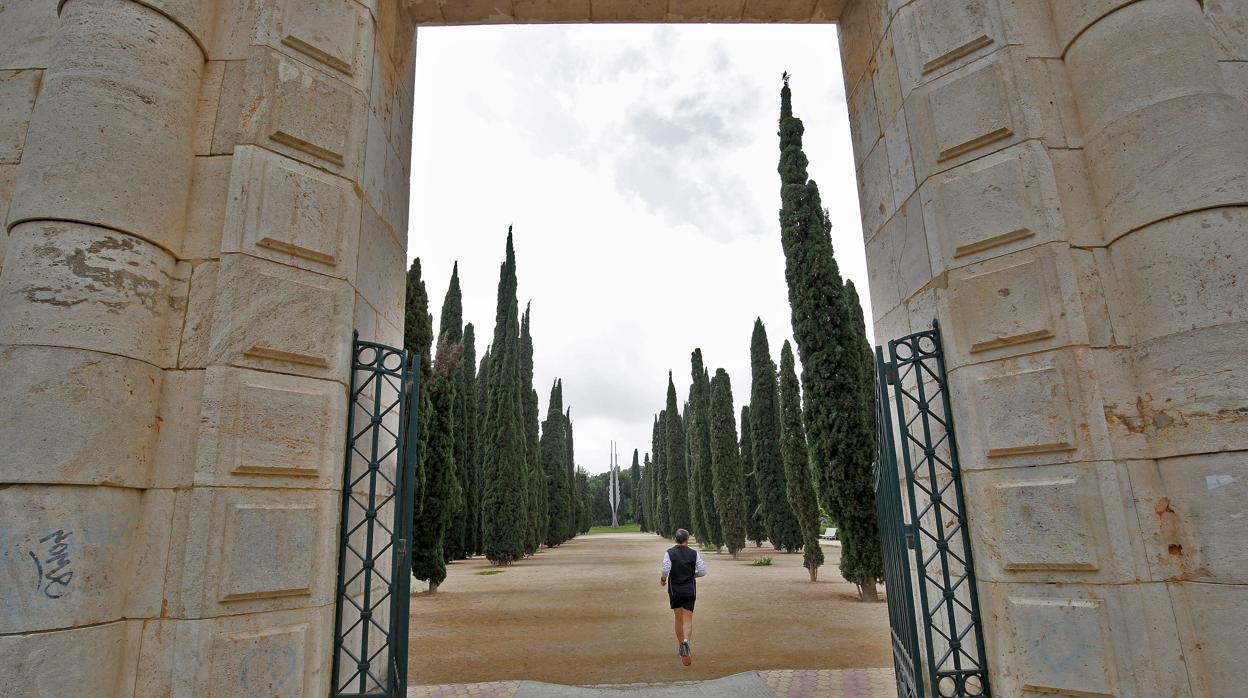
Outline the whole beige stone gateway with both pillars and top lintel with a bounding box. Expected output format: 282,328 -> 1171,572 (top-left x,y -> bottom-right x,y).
0,0 -> 1248,696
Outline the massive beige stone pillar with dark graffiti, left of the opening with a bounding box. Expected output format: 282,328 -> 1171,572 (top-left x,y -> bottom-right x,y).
0,0 -> 416,697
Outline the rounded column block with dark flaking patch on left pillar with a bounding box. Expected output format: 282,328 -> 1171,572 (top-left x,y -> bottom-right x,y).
0,221 -> 190,367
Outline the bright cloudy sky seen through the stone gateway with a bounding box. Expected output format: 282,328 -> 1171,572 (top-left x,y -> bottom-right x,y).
408,25 -> 869,472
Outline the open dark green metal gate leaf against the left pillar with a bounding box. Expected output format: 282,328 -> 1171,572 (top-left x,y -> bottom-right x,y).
329,333 -> 419,698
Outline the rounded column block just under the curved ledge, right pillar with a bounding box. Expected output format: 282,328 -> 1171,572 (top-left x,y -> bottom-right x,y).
1108,207 -> 1248,343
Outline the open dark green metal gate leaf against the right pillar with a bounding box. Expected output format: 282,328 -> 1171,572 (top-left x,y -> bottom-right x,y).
875,322 -> 992,698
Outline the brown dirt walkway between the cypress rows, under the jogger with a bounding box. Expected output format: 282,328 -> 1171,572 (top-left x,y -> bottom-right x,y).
408,533 -> 891,684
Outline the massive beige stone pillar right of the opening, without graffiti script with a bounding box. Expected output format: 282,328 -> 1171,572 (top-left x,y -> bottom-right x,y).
841,0 -> 1248,698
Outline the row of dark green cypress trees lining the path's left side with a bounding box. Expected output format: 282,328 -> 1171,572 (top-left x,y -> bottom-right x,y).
403,229 -> 590,592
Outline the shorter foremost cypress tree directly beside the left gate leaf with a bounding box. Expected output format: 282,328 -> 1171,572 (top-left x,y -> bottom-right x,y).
412,337 -> 463,593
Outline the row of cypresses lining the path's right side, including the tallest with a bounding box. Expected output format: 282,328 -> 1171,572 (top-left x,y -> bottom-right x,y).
638,74 -> 884,601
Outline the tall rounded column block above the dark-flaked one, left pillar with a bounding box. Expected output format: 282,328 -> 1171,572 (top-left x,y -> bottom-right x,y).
9,0 -> 202,250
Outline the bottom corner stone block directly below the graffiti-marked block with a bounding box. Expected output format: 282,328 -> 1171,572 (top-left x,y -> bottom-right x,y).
0,619 -> 142,697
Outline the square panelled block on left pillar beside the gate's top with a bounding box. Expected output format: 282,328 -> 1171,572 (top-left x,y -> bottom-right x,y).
208,255 -> 351,381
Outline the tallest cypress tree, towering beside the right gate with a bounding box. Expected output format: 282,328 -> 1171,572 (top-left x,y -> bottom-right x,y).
779,74 -> 884,601
